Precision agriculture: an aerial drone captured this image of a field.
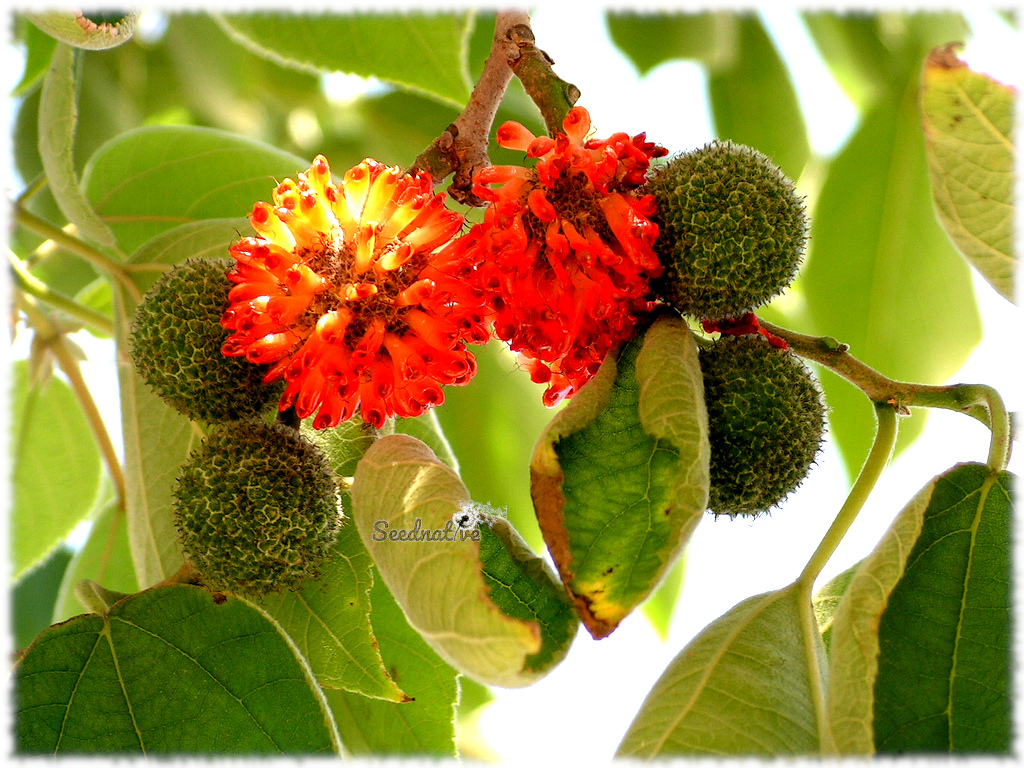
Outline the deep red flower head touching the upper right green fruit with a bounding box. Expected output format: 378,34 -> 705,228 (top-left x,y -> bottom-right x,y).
466,106 -> 668,406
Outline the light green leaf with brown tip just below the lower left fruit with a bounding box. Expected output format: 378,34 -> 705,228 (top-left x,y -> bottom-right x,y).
247,522 -> 409,701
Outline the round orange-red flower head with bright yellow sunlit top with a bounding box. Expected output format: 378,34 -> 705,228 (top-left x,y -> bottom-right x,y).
221,156 -> 489,429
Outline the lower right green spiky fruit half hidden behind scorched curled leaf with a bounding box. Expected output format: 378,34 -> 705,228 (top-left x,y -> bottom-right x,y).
699,335 -> 825,517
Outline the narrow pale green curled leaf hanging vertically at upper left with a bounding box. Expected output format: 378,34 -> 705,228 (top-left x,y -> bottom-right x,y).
39,44 -> 114,246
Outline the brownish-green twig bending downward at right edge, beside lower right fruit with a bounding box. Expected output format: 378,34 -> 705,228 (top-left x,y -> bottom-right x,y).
759,318 -> 1012,471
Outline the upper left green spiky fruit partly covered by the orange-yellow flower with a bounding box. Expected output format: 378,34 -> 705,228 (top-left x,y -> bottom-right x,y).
129,259 -> 284,423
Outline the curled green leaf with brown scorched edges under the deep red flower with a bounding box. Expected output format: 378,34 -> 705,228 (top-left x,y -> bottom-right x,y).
530,317 -> 710,639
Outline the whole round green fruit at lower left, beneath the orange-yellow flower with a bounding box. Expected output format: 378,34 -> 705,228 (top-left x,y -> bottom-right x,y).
174,421 -> 341,595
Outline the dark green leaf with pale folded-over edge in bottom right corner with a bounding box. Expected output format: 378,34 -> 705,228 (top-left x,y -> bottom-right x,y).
828,464 -> 1014,755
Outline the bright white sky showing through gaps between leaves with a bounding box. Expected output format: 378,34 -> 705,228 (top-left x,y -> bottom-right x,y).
4,3 -> 1024,765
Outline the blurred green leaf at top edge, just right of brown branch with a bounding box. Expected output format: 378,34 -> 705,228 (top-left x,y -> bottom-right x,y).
605,11 -> 739,76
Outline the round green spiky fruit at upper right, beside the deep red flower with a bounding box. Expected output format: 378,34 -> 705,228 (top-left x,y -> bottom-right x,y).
648,141 -> 807,321
